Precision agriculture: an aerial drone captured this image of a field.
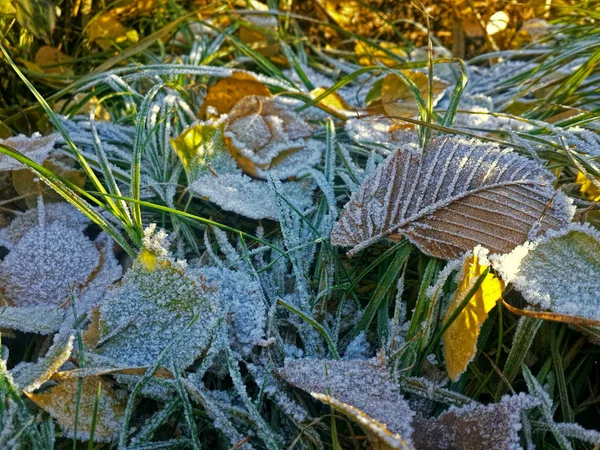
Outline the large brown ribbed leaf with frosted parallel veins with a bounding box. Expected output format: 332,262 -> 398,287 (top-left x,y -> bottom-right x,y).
331,137 -> 573,259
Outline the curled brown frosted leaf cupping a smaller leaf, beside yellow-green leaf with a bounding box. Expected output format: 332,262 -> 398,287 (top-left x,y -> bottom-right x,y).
224,95 -> 323,179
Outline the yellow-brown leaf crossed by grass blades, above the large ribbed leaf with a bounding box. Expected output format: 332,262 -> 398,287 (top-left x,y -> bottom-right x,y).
367,70 -> 448,117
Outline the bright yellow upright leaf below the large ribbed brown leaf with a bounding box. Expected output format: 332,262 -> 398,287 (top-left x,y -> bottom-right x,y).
443,255 -> 504,380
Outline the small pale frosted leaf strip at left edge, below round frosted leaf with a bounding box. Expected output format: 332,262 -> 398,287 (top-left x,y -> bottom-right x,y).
0,306 -> 65,334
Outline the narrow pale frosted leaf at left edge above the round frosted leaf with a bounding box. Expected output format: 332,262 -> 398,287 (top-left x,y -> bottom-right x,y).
0,202 -> 90,250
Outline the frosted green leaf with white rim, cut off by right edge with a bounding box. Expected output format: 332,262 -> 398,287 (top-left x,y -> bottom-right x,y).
490,224 -> 600,320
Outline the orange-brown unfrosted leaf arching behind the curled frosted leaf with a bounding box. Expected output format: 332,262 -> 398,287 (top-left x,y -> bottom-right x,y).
198,72 -> 271,117
